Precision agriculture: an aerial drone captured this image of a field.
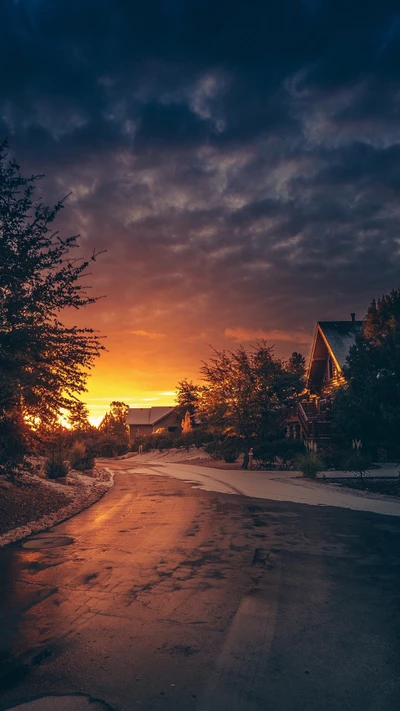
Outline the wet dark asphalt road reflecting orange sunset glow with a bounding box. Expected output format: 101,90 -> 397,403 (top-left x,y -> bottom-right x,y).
0,462 -> 400,711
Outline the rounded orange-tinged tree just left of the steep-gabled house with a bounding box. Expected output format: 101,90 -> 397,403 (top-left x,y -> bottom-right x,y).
200,341 -> 304,469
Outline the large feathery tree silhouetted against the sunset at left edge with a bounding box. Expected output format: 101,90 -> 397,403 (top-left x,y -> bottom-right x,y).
0,143 -> 103,470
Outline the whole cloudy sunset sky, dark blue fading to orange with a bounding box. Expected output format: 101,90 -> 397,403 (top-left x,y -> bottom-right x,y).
0,0 -> 400,422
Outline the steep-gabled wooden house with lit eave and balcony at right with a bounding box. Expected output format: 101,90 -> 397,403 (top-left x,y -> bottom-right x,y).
285,313 -> 362,443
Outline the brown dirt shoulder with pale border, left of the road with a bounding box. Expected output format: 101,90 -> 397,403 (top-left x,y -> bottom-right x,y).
0,467 -> 113,548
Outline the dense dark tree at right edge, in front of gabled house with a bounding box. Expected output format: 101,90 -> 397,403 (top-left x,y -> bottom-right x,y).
333,289 -> 400,456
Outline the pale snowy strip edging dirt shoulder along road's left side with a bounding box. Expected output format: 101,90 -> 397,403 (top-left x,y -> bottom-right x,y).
0,467 -> 114,548
